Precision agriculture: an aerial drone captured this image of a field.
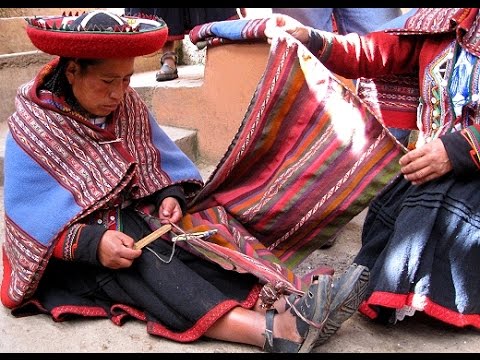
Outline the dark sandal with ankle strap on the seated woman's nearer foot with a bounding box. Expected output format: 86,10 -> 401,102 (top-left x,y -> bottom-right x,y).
263,275 -> 333,353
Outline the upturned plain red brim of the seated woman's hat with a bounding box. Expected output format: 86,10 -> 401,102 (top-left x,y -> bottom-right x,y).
27,13 -> 168,58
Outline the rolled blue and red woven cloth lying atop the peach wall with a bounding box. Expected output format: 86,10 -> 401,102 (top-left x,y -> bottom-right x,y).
189,18 -> 267,49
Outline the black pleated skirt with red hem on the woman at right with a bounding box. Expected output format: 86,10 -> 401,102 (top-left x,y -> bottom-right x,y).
354,174 -> 480,328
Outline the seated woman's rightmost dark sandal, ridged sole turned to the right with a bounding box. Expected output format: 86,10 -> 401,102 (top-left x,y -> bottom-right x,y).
315,264 -> 370,346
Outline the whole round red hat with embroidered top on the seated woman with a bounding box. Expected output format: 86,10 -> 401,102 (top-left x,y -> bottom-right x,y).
26,10 -> 168,58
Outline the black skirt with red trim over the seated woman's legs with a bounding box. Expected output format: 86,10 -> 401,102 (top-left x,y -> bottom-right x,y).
14,210 -> 260,341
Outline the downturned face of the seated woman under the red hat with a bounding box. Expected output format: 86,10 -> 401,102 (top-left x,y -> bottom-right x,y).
66,58 -> 135,116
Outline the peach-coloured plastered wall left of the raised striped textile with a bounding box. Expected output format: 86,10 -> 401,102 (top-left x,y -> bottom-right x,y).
151,43 -> 270,163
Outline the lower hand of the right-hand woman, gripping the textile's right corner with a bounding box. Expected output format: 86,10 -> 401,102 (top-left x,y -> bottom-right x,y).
399,138 -> 453,185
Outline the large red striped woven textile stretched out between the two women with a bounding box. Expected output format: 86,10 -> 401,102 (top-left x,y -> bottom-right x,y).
182,34 -> 402,284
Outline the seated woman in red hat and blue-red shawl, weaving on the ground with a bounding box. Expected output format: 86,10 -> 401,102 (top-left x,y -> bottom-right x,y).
1,10 -> 368,352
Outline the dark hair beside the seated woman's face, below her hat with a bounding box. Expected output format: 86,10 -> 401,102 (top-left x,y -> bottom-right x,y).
42,57 -> 102,117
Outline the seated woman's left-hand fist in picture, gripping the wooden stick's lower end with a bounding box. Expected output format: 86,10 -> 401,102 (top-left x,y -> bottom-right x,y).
97,230 -> 142,269
